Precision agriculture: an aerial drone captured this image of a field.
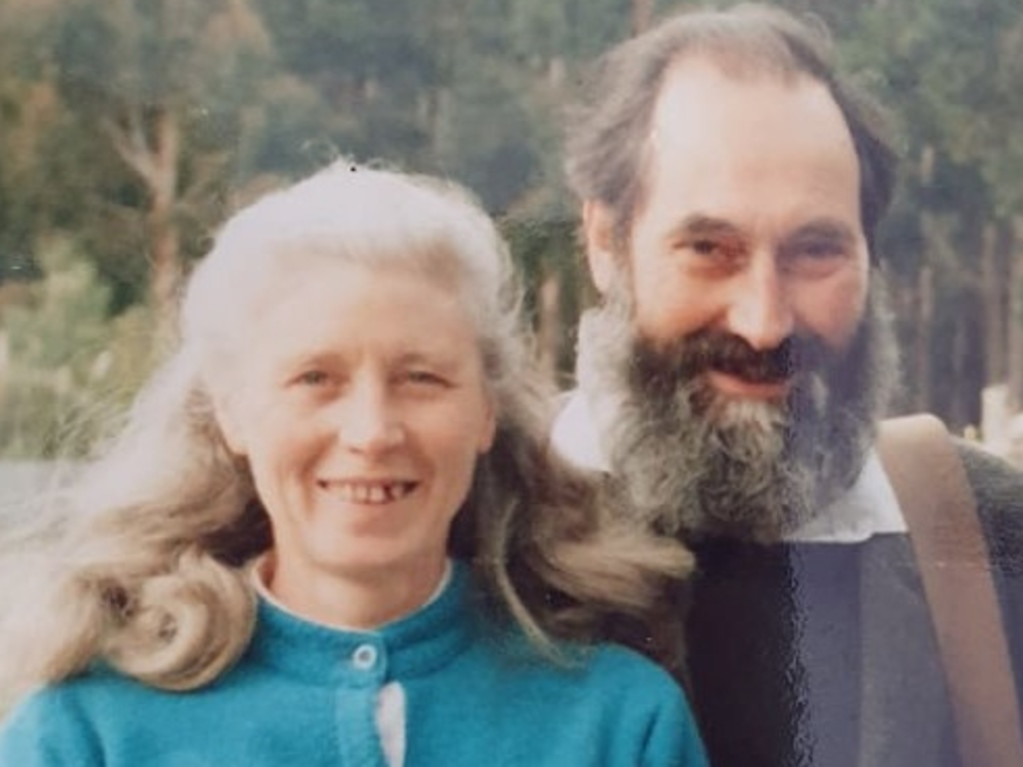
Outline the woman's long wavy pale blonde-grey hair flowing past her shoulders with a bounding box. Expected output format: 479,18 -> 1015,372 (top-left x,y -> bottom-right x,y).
0,161 -> 692,690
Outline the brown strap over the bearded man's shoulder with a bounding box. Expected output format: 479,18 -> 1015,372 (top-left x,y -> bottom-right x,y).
878,415 -> 1023,767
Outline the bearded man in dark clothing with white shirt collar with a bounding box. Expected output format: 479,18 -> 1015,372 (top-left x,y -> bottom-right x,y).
553,6 -> 1023,767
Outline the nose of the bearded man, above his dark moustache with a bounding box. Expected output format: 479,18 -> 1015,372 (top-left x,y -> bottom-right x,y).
727,255 -> 795,351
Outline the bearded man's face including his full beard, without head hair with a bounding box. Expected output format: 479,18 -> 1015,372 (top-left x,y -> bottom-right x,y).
581,59 -> 890,538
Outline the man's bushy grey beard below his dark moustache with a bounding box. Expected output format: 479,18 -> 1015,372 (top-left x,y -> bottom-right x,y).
577,269 -> 897,542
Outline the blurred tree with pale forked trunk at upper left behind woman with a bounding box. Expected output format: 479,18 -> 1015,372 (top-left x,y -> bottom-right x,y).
41,0 -> 271,333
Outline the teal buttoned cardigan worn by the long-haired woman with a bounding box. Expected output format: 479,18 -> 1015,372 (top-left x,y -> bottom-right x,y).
0,565 -> 706,767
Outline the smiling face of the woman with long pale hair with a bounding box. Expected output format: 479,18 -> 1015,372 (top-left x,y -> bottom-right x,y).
218,261 -> 495,587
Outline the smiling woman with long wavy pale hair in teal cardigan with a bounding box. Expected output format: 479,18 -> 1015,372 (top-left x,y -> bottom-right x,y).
0,164 -> 704,767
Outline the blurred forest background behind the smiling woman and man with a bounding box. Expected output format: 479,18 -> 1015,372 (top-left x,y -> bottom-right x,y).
0,0 -> 1023,468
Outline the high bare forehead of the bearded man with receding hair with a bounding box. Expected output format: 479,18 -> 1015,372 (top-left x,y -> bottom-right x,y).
631,55 -> 862,259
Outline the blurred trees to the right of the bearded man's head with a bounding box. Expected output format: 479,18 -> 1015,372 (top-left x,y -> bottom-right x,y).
842,0 -> 1023,427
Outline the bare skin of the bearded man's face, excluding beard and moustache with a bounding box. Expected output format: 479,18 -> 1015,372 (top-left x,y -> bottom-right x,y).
587,59 -> 869,409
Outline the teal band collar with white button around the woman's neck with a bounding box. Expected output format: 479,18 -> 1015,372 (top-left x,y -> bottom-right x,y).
248,561 -> 475,687
